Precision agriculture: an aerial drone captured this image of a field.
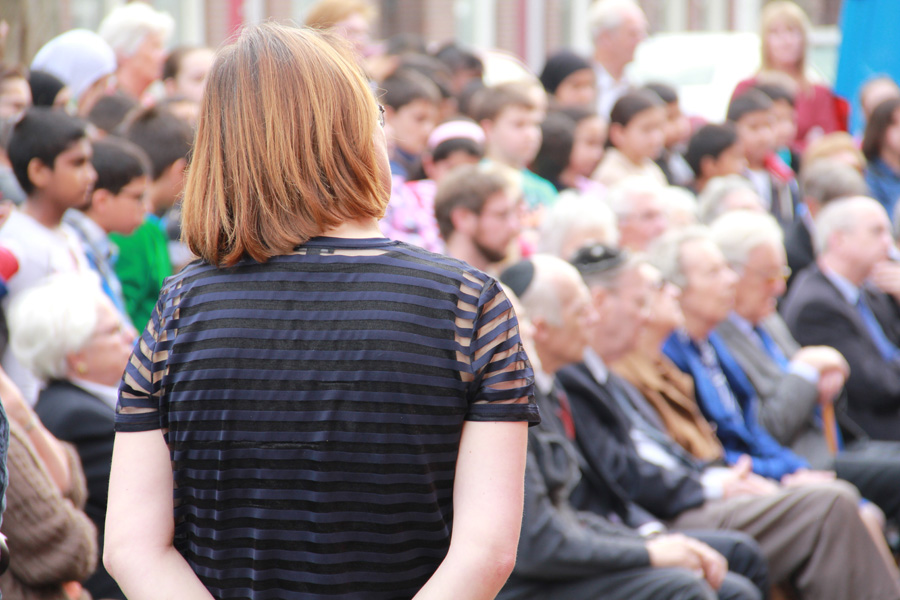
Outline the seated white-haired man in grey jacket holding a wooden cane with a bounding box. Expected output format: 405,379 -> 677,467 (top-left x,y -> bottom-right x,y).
712,212 -> 900,519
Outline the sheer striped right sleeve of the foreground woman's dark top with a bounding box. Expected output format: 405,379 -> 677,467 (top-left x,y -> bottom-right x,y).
466,279 -> 540,424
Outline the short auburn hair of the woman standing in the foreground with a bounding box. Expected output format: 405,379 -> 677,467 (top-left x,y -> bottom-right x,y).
182,23 -> 390,266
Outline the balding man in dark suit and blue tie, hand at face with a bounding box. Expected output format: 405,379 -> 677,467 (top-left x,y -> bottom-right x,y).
781,196 -> 900,440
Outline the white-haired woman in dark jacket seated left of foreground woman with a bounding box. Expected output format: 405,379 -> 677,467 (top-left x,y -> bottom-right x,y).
9,275 -> 134,598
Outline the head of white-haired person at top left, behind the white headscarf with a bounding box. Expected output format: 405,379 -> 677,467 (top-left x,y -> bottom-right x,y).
98,2 -> 175,100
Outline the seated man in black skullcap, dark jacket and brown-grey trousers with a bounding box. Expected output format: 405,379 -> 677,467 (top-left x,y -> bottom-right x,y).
556,247 -> 898,599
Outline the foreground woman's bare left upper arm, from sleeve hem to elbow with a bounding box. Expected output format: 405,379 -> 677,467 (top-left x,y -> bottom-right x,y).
104,429 -> 175,562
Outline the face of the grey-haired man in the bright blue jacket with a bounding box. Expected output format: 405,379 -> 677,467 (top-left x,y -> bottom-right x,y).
681,239 -> 737,329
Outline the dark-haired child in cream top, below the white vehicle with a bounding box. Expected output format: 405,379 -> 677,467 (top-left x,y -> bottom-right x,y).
593,90 -> 666,187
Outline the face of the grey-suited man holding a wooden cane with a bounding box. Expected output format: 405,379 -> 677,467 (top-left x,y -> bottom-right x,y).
734,243 -> 789,325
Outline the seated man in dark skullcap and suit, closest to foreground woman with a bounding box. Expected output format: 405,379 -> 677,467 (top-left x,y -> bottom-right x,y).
498,255 -> 768,600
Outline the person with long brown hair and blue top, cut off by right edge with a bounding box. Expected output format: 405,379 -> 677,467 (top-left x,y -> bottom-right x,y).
862,98 -> 900,219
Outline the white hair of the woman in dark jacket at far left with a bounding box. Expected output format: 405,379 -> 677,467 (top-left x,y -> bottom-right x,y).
8,273 -> 106,381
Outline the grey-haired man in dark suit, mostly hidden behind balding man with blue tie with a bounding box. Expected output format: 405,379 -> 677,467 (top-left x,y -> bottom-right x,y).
784,159 -> 868,287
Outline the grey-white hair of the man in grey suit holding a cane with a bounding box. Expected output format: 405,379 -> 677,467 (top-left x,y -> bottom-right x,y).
709,210 -> 784,268
